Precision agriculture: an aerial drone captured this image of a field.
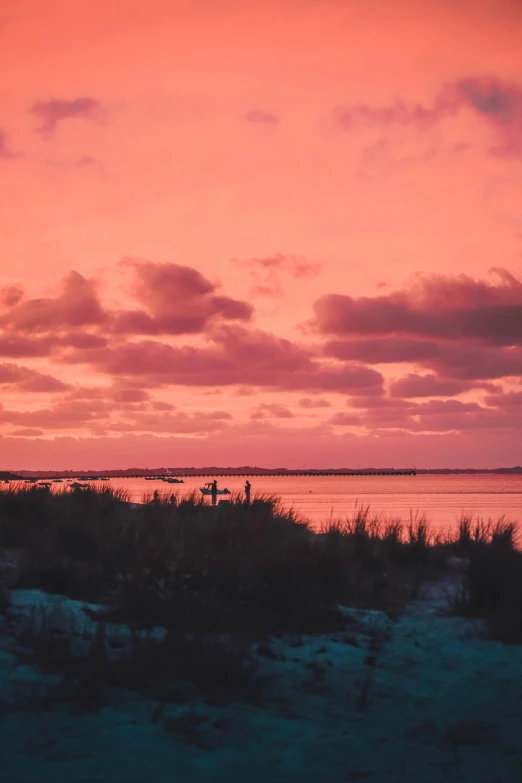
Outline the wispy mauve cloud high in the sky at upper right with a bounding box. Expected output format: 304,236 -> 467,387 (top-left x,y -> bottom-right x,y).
335,76 -> 522,157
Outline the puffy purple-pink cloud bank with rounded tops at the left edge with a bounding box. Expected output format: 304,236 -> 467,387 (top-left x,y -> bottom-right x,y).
0,260 -> 253,363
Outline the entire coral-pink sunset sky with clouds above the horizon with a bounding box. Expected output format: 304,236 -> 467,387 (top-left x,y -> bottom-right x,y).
0,0 -> 522,469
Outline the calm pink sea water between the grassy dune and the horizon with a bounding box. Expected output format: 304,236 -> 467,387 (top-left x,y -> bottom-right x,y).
100,474 -> 522,528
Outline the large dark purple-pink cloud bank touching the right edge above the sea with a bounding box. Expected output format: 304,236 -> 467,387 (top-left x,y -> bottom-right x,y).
309,269 -> 522,384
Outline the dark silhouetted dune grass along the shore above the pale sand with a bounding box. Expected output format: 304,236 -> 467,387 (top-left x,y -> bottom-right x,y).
0,485 -> 522,648
